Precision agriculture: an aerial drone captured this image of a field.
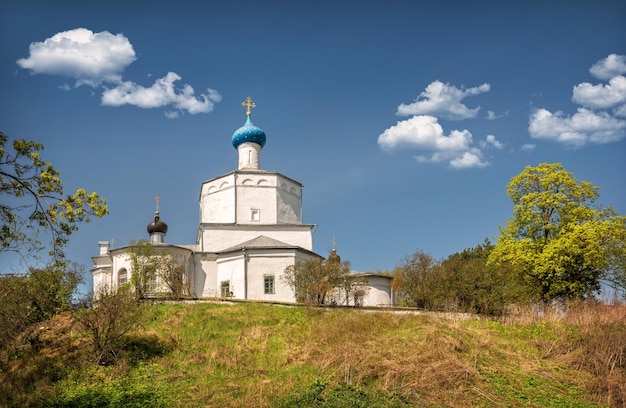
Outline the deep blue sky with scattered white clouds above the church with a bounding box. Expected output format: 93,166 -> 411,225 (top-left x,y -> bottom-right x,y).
0,0 -> 626,294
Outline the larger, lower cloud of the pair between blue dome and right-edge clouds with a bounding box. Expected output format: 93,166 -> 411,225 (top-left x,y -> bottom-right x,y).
378,115 -> 488,168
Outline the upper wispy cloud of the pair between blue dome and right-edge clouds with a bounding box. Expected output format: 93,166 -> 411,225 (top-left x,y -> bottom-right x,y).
396,81 -> 490,120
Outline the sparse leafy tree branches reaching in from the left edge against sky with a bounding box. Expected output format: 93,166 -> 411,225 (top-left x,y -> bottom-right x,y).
0,132 -> 108,261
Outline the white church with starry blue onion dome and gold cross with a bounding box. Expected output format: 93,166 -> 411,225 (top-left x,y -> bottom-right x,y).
91,97 -> 394,306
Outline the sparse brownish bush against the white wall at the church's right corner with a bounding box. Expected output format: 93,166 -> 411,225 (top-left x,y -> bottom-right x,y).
281,250 -> 363,305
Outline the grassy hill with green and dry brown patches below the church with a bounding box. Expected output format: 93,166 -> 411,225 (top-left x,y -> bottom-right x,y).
0,303 -> 626,407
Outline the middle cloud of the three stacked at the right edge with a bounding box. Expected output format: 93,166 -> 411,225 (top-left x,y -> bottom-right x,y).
572,75 -> 626,109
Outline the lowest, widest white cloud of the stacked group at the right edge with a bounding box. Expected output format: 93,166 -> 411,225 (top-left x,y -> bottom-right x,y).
528,108 -> 626,147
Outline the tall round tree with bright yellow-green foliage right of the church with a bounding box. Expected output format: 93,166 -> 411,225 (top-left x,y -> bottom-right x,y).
489,163 -> 626,301
